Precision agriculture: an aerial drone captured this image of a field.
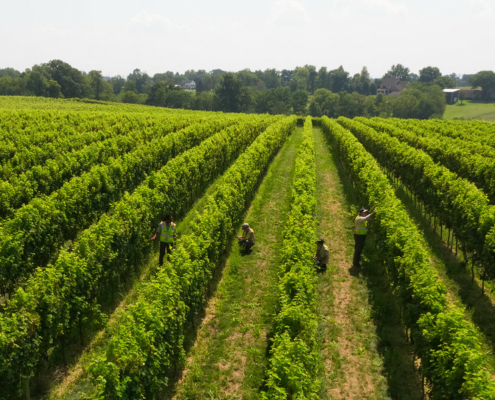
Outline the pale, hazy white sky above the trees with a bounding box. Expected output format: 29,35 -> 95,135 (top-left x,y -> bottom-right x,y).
0,0 -> 495,78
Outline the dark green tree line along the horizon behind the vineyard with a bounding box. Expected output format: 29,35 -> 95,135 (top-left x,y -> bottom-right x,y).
0,60 -> 495,119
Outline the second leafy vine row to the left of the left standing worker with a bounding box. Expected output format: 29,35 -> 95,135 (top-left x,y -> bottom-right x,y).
0,117 -> 252,292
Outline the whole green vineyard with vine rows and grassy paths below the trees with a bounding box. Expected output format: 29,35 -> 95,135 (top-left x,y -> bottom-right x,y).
0,97 -> 495,400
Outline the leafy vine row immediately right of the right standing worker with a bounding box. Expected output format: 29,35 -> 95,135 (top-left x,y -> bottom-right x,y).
322,117 -> 495,399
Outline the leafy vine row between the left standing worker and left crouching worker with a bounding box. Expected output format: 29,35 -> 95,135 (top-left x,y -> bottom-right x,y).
58,117 -> 296,399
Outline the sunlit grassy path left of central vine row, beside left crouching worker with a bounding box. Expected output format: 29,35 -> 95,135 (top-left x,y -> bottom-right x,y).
169,129 -> 301,399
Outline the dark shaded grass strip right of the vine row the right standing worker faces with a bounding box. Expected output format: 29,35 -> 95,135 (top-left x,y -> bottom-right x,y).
396,183 -> 495,353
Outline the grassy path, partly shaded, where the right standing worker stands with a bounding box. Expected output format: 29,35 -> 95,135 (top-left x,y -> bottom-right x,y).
314,129 -> 422,400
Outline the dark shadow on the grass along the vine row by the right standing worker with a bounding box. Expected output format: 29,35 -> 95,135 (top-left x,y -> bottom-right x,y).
328,134 -> 422,400
